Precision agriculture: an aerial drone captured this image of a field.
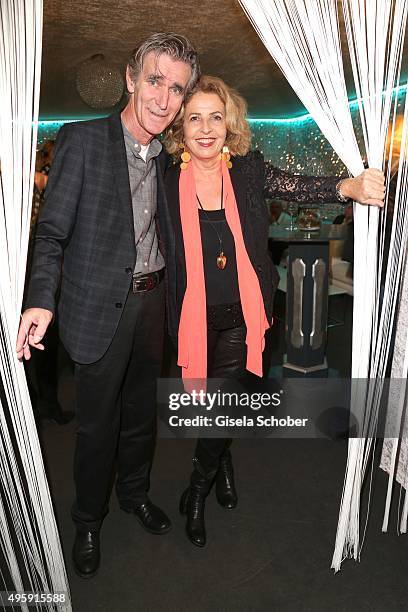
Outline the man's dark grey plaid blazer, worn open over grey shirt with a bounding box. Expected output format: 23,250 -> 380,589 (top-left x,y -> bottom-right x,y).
26,113 -> 171,363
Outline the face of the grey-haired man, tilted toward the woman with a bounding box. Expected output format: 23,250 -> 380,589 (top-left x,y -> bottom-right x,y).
125,51 -> 191,144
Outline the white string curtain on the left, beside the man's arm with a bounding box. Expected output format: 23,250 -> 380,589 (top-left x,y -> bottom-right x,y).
0,0 -> 71,610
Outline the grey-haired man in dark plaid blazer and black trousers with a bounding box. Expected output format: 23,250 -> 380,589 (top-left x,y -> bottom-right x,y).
17,34 -> 199,578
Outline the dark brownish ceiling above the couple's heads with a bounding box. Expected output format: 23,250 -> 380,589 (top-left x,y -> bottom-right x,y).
40,0 -> 404,119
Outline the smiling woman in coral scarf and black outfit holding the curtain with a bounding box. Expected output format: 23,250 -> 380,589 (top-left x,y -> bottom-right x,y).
163,76 -> 384,546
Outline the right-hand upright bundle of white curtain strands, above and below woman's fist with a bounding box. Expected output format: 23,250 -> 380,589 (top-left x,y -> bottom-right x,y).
332,0 -> 407,571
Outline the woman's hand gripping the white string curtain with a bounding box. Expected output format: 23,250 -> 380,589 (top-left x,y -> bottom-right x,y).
339,168 -> 385,207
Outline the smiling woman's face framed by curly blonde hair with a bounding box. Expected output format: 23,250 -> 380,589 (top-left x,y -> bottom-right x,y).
183,92 -> 227,160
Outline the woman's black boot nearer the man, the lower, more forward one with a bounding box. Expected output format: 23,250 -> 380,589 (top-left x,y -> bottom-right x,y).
180,457 -> 216,546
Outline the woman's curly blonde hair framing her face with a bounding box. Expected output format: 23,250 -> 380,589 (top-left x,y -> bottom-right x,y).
164,75 -> 251,160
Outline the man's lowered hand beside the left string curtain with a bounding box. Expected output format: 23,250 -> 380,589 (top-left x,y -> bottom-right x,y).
16,308 -> 54,361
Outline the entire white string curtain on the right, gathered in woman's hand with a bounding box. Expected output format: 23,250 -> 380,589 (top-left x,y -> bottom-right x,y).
240,0 -> 407,571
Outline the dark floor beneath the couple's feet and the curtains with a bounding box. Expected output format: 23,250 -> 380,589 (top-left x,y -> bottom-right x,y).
3,295 -> 408,612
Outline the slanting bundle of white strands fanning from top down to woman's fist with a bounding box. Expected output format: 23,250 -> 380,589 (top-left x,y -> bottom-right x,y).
240,0 -> 364,175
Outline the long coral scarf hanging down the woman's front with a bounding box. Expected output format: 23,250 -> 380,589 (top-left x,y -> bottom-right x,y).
177,161 -> 269,379
